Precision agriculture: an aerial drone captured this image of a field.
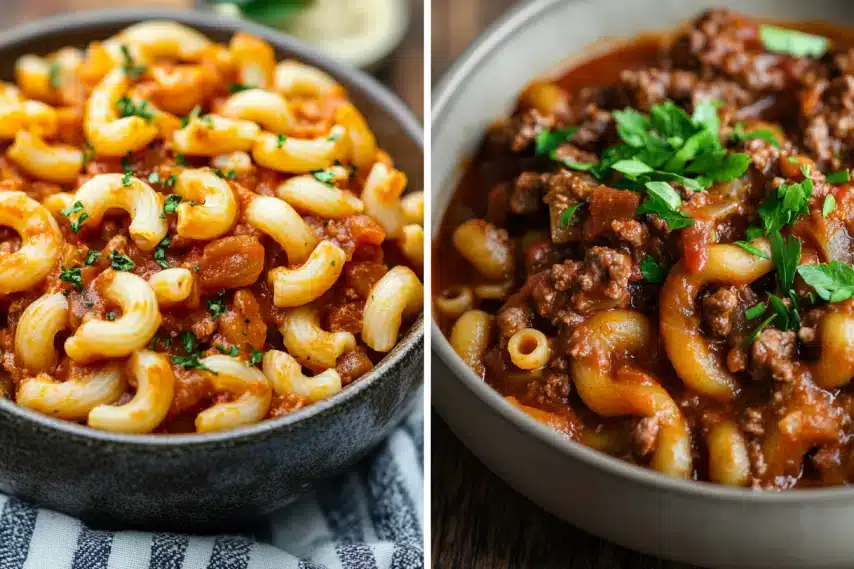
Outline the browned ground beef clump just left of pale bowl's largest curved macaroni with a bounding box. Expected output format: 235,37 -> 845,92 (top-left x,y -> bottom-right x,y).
550,247 -> 632,313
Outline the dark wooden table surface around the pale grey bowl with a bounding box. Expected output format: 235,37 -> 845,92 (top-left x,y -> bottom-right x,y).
431,0 -> 689,569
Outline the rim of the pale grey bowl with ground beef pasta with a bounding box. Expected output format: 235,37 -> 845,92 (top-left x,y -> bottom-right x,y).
430,0 -> 854,506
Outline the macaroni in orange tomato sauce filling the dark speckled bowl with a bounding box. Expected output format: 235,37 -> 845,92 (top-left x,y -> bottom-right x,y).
0,21 -> 423,433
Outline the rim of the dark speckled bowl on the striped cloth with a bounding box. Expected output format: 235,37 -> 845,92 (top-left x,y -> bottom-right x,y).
0,8 -> 424,449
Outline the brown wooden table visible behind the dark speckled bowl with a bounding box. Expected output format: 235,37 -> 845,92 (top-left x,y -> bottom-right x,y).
0,0 -> 424,120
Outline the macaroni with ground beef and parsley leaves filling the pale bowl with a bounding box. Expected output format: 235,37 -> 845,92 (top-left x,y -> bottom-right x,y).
433,10 -> 854,490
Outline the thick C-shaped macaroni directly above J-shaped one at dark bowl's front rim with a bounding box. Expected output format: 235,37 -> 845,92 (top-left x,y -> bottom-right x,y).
65,269 -> 161,363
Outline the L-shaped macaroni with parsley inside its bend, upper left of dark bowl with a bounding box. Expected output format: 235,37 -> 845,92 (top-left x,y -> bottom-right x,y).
83,68 -> 159,156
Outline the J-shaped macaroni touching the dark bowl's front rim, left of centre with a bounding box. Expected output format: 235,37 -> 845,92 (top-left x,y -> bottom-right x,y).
88,350 -> 175,433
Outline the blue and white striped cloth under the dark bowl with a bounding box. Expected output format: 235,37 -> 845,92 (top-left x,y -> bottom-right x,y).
0,406 -> 424,569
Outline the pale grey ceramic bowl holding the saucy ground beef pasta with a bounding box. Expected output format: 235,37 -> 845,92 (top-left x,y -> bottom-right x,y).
438,0 -> 854,569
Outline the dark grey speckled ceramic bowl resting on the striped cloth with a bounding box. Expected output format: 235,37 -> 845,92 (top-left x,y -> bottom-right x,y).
0,10 -> 423,531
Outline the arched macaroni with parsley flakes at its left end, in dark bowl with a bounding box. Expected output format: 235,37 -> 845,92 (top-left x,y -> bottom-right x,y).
69,170 -> 169,247
